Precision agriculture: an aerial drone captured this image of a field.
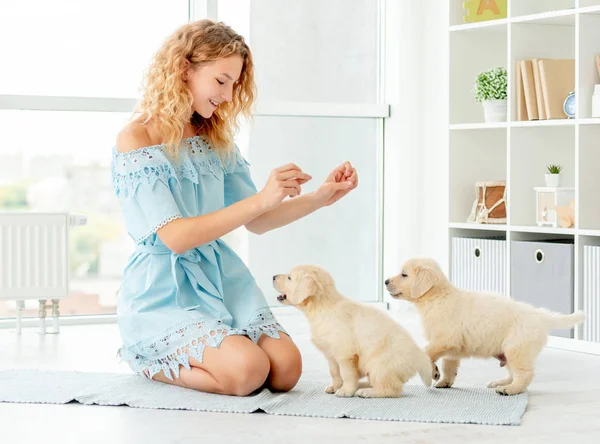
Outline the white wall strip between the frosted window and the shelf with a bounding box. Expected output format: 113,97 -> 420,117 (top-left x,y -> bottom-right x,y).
384,0 -> 448,302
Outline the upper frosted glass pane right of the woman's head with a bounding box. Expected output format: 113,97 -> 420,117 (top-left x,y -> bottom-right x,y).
218,0 -> 379,103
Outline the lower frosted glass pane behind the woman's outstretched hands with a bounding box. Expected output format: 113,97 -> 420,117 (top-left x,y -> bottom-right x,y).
243,117 -> 381,304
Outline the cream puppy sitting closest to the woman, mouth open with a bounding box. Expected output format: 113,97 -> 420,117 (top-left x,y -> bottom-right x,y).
273,266 -> 432,398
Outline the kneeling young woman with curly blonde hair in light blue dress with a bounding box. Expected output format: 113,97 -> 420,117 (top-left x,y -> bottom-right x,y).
112,20 -> 358,396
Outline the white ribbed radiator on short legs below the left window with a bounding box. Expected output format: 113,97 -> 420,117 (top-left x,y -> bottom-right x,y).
0,212 -> 86,333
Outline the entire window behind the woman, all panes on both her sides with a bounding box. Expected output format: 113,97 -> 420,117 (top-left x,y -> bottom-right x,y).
0,0 -> 385,318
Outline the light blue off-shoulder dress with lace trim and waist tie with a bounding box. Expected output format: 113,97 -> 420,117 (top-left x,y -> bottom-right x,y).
111,137 -> 285,379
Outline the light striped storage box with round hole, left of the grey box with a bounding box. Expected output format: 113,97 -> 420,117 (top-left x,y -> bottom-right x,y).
451,237 -> 506,294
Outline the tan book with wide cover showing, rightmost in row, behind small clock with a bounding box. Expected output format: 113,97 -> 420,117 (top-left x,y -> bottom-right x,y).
539,59 -> 575,119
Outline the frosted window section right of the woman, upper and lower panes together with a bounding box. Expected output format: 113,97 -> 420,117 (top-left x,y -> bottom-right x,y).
218,0 -> 383,304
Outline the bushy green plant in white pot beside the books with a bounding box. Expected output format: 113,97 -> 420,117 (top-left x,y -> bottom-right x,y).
473,67 -> 508,122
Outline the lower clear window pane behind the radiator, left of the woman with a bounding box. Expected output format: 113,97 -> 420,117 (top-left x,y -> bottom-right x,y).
0,110 -> 133,317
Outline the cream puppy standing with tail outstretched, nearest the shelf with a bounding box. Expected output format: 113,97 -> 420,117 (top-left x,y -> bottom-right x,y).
385,258 -> 585,395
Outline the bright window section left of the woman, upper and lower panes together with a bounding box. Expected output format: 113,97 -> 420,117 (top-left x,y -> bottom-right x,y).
0,0 -> 189,318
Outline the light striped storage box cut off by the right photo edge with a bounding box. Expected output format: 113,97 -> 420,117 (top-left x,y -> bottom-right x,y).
583,245 -> 600,342
